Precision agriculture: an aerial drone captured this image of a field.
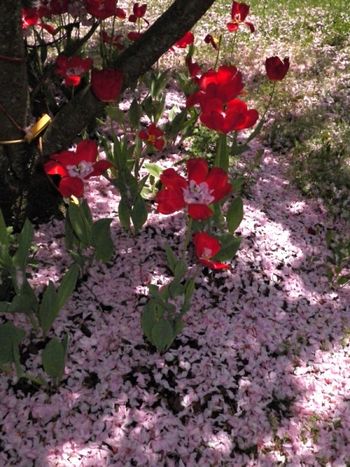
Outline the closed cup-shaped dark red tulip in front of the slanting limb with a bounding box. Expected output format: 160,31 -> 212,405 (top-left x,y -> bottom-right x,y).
91,68 -> 123,102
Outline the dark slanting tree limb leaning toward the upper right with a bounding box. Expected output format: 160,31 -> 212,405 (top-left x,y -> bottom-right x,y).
44,0 -> 215,155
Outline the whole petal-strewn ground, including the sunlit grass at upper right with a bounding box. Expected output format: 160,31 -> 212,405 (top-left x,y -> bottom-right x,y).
0,0 -> 350,467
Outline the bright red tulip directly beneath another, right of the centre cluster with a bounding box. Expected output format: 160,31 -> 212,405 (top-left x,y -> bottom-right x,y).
200,98 -> 259,134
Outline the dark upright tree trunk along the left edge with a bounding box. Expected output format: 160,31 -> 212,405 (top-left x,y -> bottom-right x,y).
0,0 -> 30,227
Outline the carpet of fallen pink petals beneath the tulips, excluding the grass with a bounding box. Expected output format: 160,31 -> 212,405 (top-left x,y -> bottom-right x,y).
0,141 -> 350,467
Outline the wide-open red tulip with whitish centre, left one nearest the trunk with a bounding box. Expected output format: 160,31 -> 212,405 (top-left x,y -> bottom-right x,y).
44,140 -> 112,198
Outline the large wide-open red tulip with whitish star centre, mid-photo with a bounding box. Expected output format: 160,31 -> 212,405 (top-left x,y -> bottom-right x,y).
156,159 -> 232,220
